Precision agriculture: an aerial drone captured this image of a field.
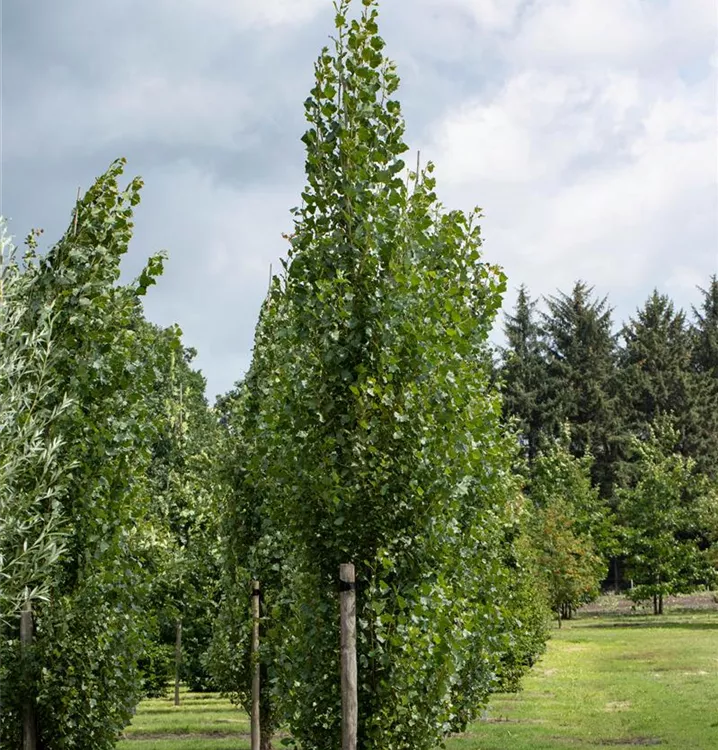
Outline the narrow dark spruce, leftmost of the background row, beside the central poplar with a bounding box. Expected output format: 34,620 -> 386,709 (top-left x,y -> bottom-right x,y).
501,284 -> 547,462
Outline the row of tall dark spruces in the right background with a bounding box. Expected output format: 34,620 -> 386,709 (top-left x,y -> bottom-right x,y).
497,275 -> 718,610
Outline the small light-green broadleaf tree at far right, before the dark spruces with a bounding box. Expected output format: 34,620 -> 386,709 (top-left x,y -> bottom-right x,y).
618,420 -> 711,613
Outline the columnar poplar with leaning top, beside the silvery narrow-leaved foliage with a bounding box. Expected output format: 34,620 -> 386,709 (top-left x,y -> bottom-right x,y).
0,161 -> 170,750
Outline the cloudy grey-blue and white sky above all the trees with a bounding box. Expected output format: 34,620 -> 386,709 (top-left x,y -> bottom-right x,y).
0,0 -> 718,400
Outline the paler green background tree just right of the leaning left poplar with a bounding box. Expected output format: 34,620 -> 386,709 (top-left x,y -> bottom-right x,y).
145,338 -> 221,690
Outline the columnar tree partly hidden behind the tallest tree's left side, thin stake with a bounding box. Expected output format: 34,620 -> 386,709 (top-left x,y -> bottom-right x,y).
210,286 -> 293,750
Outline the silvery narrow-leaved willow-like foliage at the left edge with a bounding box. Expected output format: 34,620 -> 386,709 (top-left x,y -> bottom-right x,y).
0,221 -> 72,627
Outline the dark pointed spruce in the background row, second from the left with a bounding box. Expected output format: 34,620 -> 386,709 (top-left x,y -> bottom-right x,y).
543,281 -> 618,498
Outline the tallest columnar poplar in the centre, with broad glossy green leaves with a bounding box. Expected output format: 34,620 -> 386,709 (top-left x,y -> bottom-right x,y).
228,0 -> 540,750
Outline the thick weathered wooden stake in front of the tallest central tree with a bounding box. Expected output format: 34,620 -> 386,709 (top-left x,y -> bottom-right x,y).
339,563 -> 359,750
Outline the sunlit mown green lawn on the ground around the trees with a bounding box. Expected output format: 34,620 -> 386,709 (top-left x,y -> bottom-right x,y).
118,599 -> 718,750
